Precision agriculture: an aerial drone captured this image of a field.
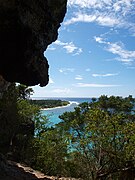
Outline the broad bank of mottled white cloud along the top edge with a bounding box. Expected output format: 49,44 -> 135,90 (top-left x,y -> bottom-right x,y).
64,0 -> 135,32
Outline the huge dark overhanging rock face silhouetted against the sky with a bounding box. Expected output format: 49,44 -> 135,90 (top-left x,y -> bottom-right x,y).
0,0 -> 67,86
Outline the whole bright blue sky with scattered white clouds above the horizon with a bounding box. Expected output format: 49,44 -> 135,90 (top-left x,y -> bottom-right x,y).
32,0 -> 135,97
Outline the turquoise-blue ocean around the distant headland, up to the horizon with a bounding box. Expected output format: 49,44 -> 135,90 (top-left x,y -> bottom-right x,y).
34,97 -> 91,125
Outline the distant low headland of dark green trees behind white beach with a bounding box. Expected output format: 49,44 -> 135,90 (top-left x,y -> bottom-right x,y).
30,99 -> 69,108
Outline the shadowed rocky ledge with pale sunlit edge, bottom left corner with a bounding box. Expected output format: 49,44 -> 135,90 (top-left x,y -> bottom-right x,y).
0,155 -> 81,180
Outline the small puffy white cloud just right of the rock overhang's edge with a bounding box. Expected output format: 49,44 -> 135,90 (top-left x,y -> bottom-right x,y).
54,40 -> 82,55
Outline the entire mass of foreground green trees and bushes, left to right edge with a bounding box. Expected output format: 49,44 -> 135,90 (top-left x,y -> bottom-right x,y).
0,84 -> 135,180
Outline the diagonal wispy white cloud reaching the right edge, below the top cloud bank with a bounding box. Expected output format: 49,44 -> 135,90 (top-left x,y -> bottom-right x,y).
94,37 -> 135,65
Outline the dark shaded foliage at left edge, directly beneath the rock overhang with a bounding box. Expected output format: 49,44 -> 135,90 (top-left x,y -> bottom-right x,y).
0,83 -> 40,161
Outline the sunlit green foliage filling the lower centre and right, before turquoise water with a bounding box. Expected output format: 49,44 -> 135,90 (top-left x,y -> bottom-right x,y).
26,96 -> 135,180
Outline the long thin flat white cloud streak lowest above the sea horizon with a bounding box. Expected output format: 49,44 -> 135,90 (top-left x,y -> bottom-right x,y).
75,83 -> 121,88
